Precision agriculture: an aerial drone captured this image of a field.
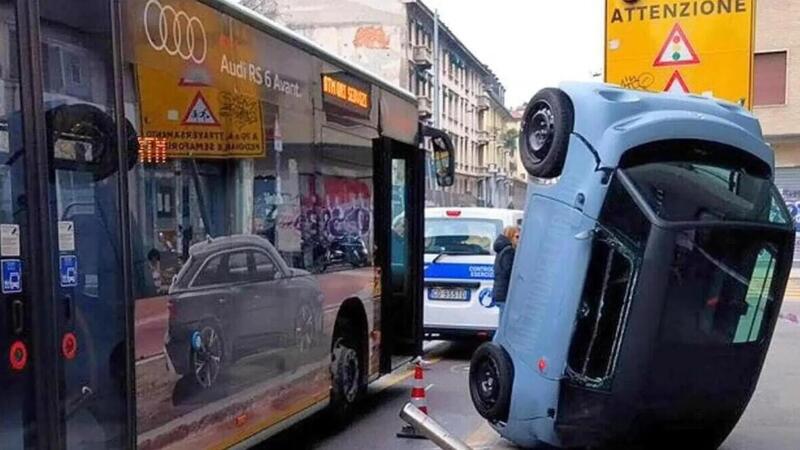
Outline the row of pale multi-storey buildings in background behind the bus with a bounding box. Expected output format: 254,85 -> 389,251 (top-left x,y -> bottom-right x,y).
242,0 -> 524,208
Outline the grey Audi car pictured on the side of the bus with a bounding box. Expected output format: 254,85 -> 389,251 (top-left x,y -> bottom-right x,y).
166,235 -> 323,388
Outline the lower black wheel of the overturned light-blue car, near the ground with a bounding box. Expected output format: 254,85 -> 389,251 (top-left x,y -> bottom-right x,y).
469,342 -> 514,422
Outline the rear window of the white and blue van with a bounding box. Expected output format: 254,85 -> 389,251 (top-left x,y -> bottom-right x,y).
425,219 -> 503,255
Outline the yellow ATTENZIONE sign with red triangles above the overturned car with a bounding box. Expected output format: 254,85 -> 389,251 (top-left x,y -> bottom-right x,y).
605,0 -> 755,108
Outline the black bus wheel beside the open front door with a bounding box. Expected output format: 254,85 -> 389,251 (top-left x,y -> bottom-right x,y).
331,318 -> 364,422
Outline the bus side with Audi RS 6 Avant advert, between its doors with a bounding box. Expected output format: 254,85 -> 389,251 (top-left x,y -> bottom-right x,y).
122,0 -> 388,449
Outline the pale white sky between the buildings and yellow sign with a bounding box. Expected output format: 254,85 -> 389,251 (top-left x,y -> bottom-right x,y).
423,0 -> 605,107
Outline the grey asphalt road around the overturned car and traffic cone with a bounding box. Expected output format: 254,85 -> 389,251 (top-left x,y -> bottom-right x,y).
259,302 -> 800,450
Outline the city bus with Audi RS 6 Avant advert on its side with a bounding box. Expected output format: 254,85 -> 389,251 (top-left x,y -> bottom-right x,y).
0,0 -> 453,449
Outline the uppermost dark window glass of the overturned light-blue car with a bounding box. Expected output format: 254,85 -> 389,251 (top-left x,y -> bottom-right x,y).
624,162 -> 792,225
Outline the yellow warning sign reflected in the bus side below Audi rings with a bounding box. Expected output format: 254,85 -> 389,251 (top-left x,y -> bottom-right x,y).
137,65 -> 265,159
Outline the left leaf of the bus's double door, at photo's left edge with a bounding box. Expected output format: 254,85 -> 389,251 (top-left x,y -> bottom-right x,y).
0,0 -> 33,448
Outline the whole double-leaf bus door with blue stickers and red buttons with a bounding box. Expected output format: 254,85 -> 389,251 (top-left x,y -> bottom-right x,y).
0,0 -> 136,449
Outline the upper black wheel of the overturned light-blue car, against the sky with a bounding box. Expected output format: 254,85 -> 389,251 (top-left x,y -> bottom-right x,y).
519,88 -> 575,178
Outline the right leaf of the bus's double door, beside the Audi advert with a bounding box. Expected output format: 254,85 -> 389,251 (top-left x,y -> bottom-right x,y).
38,0 -> 137,449
